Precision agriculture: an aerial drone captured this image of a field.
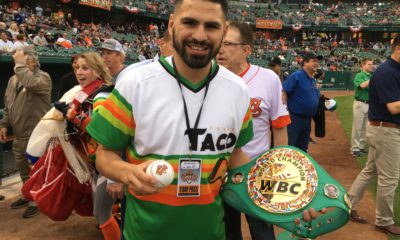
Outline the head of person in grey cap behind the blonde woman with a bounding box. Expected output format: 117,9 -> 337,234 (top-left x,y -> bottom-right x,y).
99,38 -> 125,84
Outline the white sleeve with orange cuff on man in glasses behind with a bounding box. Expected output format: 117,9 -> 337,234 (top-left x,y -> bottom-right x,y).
270,74 -> 291,128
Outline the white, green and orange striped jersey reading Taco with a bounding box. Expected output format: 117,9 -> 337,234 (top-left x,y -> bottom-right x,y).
87,58 -> 253,240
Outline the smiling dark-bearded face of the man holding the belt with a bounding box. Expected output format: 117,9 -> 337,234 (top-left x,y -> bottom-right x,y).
169,0 -> 226,68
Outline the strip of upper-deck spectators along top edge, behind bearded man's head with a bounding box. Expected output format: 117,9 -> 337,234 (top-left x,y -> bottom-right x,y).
115,0 -> 400,26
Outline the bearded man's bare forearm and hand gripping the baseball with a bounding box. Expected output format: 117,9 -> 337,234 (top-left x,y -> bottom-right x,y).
96,144 -> 160,195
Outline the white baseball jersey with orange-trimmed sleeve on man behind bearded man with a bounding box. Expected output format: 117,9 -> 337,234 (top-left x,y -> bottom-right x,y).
239,65 -> 290,159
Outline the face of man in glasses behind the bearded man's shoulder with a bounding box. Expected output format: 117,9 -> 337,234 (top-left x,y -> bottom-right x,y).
217,27 -> 247,73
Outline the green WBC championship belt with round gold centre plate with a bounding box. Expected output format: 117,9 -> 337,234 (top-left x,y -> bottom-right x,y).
221,146 -> 351,240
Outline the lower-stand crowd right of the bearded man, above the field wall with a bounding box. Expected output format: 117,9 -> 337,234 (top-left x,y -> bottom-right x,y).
251,32 -> 390,72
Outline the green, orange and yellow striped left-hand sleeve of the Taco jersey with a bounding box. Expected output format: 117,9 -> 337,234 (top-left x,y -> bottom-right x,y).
86,84 -> 135,150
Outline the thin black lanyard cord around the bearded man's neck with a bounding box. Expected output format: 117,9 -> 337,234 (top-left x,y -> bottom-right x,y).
172,59 -> 212,152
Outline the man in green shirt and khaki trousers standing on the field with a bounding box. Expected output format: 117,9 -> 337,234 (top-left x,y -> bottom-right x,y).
350,58 -> 374,157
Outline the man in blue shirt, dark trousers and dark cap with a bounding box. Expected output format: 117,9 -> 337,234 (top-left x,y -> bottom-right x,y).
283,52 -> 321,152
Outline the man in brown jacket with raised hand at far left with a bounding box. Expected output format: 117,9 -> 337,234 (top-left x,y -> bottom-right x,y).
0,47 -> 52,218
